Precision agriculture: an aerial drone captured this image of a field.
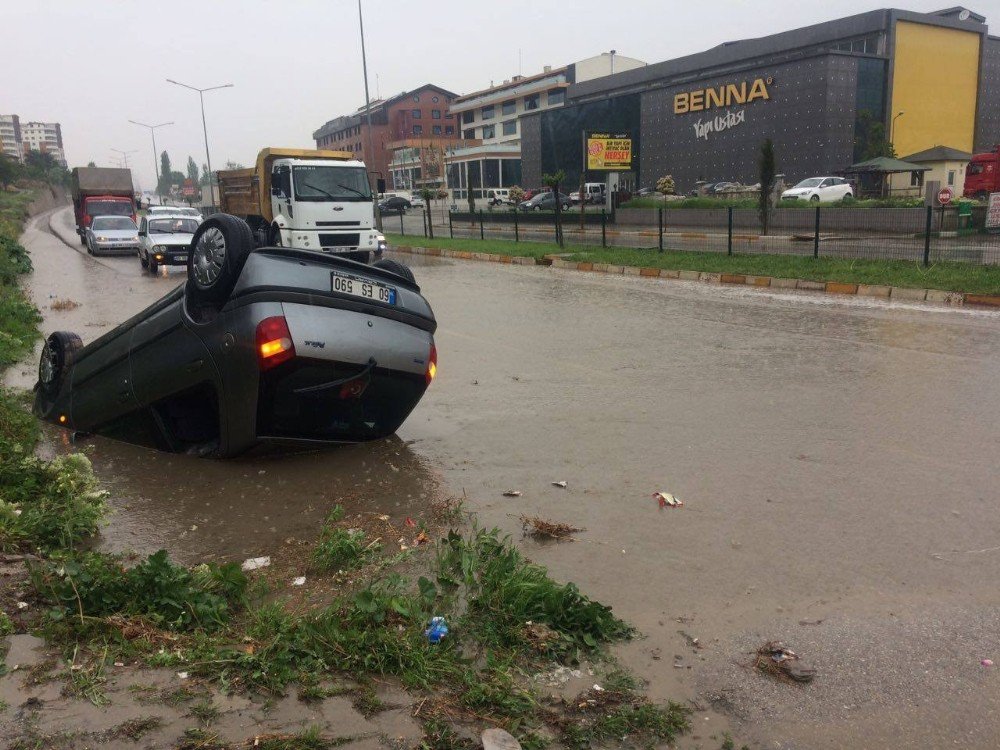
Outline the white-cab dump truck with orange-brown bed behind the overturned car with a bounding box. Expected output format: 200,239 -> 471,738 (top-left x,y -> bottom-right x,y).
217,148 -> 385,262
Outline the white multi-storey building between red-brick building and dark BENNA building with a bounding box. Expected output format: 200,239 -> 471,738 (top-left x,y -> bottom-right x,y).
445,51 -> 646,200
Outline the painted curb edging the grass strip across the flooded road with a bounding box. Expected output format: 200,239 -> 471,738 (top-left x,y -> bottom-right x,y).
391,245 -> 1000,309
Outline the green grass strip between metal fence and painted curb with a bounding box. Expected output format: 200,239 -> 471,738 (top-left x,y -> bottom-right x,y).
389,235 -> 1000,294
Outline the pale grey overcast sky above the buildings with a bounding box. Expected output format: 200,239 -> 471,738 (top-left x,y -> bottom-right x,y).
0,0 -> 964,188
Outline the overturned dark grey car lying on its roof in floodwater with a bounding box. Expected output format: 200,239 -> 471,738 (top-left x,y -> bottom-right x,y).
34,214 -> 437,457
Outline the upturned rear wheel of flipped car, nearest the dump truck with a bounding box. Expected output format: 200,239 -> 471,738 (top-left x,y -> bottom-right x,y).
187,214 -> 253,304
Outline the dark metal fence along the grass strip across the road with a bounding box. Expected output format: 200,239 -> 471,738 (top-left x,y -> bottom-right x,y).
396,206 -> 1000,265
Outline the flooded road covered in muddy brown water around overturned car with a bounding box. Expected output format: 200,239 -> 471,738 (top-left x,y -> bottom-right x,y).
12,210 -> 1000,748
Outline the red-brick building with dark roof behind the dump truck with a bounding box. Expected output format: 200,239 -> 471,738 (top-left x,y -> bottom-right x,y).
313,84 -> 459,191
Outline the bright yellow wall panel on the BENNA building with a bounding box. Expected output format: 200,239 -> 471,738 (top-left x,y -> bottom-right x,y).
890,21 -> 981,154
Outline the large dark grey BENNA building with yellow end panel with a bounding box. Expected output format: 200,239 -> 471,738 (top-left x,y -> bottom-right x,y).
520,8 -> 1000,192
